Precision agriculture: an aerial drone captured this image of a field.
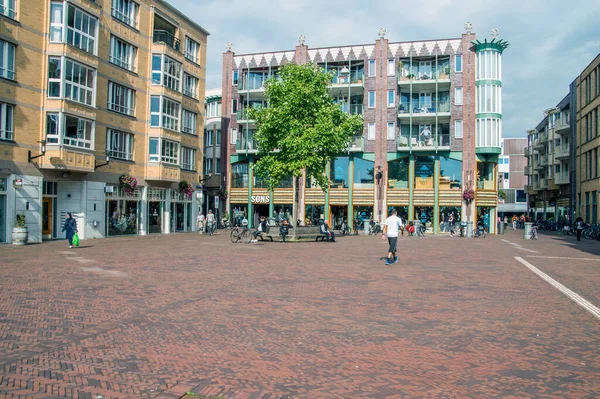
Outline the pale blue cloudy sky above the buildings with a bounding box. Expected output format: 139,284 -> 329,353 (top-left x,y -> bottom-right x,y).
169,0 -> 600,137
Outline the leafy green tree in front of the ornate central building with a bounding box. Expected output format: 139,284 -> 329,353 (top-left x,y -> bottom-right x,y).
248,64 -> 363,220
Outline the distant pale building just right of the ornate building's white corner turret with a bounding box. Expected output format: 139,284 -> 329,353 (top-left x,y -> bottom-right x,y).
498,138 -> 527,218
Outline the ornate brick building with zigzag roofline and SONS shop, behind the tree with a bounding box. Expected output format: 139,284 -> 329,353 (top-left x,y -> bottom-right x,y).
221,24 -> 508,233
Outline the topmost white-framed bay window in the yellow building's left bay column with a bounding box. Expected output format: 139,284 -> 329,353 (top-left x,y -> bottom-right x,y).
50,2 -> 98,54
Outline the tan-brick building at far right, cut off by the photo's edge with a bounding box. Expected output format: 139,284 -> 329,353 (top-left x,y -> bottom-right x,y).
571,54 -> 600,224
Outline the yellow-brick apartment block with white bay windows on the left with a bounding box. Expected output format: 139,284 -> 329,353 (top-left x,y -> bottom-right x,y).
0,0 -> 208,242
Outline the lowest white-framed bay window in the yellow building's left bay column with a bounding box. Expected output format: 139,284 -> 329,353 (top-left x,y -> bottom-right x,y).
46,112 -> 94,149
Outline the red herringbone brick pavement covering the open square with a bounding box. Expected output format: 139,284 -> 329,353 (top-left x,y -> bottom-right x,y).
0,231 -> 600,399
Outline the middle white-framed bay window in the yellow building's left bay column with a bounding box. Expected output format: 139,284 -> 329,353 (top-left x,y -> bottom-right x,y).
48,57 -> 96,106
